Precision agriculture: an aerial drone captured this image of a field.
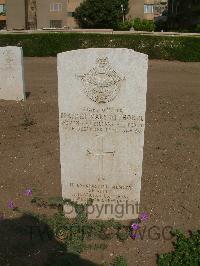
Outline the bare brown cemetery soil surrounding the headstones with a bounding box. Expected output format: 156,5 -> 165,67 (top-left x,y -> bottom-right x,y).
0,58 -> 200,266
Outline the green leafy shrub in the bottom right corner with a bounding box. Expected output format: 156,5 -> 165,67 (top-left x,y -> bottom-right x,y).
158,231 -> 200,266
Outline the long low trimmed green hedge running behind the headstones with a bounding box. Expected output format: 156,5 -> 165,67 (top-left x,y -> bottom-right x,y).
0,33 -> 200,62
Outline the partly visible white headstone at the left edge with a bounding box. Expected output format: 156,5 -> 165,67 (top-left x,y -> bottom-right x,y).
0,46 -> 25,101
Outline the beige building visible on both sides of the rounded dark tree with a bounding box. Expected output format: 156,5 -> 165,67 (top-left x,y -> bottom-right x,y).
6,0 -> 165,30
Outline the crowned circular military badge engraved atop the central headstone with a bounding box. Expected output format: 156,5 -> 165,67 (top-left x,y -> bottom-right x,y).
79,57 -> 125,103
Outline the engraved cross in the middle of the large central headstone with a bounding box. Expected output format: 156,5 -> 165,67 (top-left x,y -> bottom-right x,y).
87,136 -> 115,181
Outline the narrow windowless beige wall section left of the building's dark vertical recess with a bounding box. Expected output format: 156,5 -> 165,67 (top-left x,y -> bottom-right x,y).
6,0 -> 25,30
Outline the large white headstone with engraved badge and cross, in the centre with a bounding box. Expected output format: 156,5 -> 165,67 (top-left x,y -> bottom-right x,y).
58,48 -> 148,220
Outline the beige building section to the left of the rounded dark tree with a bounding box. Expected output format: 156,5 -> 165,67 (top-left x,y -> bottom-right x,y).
6,0 -> 83,30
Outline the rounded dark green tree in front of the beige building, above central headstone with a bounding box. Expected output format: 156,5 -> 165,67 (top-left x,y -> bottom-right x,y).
74,0 -> 128,29
